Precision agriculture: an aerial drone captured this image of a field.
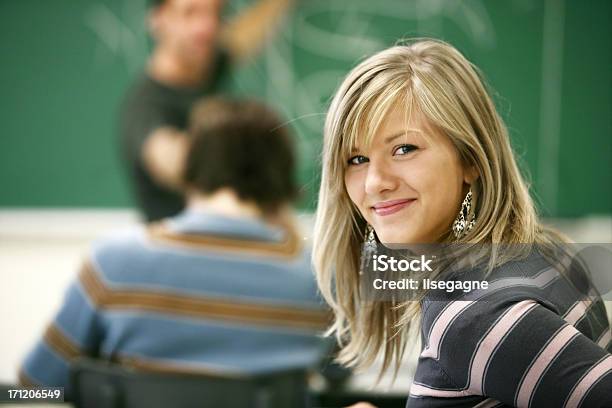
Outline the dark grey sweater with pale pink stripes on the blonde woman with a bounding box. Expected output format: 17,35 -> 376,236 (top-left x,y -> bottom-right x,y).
407,252 -> 612,408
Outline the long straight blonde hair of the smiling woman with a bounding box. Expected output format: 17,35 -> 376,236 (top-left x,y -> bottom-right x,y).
313,39 -> 563,375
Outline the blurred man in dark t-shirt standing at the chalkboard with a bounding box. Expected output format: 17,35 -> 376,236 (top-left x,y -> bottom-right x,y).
120,0 -> 292,221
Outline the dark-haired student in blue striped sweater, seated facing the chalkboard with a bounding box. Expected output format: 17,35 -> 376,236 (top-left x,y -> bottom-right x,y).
20,98 -> 328,396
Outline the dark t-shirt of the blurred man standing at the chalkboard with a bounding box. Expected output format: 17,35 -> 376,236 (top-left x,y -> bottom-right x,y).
119,52 -> 229,221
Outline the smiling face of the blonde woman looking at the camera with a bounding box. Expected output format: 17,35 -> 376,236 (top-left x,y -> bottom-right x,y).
344,104 -> 472,244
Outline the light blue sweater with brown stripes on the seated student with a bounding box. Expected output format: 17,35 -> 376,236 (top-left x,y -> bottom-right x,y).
20,211 -> 328,394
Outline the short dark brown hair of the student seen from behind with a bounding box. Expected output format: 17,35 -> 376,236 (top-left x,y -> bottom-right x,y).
184,97 -> 296,213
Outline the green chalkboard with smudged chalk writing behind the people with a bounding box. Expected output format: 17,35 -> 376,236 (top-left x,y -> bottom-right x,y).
0,0 -> 612,216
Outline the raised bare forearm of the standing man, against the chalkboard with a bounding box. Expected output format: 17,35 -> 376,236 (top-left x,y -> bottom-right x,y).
221,0 -> 293,62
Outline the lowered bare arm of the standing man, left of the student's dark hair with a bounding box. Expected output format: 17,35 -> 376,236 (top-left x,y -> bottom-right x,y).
142,127 -> 189,191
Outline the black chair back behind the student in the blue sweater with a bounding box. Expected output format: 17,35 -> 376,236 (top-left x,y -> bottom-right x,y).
70,359 -> 310,408
